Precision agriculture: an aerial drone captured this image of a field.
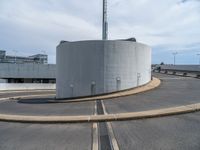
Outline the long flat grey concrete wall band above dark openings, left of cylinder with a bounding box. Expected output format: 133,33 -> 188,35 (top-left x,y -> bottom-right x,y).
0,63 -> 56,79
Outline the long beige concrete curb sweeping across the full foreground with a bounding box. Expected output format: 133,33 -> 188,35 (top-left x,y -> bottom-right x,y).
0,103 -> 200,123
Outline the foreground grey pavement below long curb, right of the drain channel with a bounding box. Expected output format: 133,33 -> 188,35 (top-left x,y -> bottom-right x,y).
112,112 -> 200,150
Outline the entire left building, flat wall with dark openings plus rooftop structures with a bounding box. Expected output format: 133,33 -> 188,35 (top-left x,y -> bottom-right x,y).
0,50 -> 53,83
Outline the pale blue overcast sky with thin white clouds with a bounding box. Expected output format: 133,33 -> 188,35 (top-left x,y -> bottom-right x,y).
0,0 -> 200,64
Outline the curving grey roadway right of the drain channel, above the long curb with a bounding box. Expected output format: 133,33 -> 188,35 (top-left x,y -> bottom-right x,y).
104,73 -> 200,113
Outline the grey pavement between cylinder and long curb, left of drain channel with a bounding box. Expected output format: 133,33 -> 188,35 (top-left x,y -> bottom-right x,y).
0,98 -> 94,116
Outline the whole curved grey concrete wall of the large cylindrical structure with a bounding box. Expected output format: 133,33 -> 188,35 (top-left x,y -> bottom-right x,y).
56,41 -> 151,98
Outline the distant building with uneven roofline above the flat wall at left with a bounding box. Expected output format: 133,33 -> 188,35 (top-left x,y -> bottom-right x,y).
0,50 -> 48,64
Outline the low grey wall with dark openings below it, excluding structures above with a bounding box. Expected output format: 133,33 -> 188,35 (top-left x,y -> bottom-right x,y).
0,63 -> 56,83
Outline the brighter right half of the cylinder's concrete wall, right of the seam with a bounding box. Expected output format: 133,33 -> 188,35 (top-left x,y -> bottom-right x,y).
104,41 -> 151,92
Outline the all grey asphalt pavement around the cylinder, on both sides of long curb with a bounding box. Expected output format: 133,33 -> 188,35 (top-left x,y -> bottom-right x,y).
0,73 -> 200,150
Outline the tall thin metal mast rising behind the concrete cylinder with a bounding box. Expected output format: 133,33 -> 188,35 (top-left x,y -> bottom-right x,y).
102,0 -> 108,40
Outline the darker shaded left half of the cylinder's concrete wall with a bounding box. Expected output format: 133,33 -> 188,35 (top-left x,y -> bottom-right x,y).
56,42 -> 104,98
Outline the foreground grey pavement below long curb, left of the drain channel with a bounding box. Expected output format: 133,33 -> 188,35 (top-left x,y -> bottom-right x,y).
0,122 -> 92,150
